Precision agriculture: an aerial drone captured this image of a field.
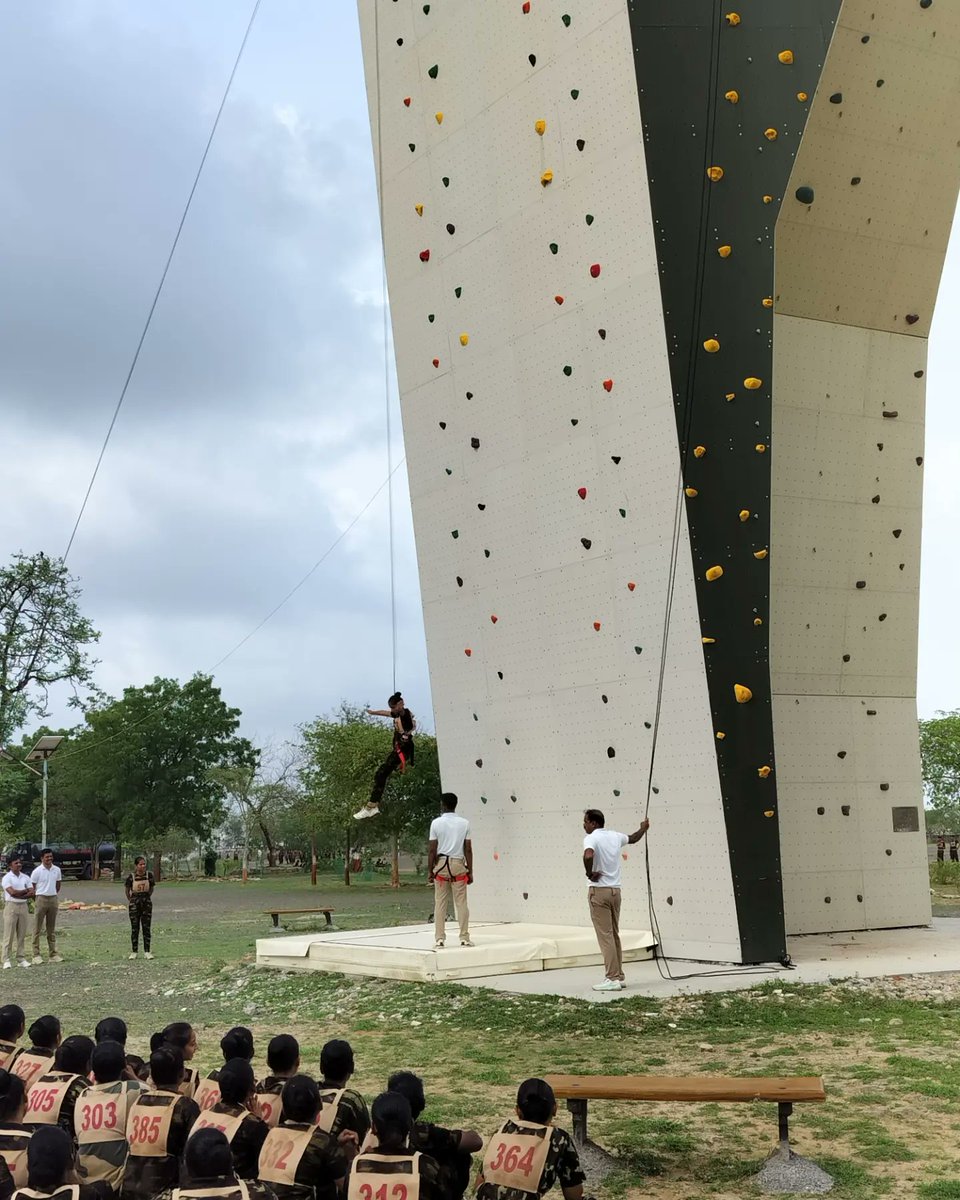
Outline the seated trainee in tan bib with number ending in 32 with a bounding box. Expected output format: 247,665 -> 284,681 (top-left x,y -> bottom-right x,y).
259,1075 -> 356,1200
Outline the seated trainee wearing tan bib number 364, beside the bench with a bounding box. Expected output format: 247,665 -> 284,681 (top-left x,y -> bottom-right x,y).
476,1079 -> 587,1200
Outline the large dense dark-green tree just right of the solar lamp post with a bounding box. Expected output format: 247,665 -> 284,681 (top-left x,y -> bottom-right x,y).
56,674 -> 256,878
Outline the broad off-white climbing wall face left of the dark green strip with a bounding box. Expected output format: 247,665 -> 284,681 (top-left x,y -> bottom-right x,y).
359,0 -> 740,960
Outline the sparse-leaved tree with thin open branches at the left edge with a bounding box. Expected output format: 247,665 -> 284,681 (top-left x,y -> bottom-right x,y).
0,553 -> 100,744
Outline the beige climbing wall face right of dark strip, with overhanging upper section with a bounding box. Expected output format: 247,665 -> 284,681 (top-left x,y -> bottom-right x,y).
770,0 -> 960,932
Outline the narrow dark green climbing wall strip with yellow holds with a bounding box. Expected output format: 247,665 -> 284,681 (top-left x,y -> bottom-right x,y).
629,0 -> 840,962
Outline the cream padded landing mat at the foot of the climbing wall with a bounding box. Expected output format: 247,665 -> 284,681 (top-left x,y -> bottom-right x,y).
257,922 -> 654,991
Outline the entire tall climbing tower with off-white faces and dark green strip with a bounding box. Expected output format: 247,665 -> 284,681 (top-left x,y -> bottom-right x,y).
359,0 -> 956,961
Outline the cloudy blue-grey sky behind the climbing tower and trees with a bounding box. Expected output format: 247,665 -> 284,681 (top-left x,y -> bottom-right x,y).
0,0 -> 960,738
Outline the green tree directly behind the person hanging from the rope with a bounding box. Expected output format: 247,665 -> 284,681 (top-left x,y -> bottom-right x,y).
300,703 -> 440,887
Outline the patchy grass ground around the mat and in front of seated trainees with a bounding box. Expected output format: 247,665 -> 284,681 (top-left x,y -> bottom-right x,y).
11,875 -> 960,1200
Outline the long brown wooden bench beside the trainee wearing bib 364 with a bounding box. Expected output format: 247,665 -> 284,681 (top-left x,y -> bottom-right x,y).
544,1075 -> 827,1156
